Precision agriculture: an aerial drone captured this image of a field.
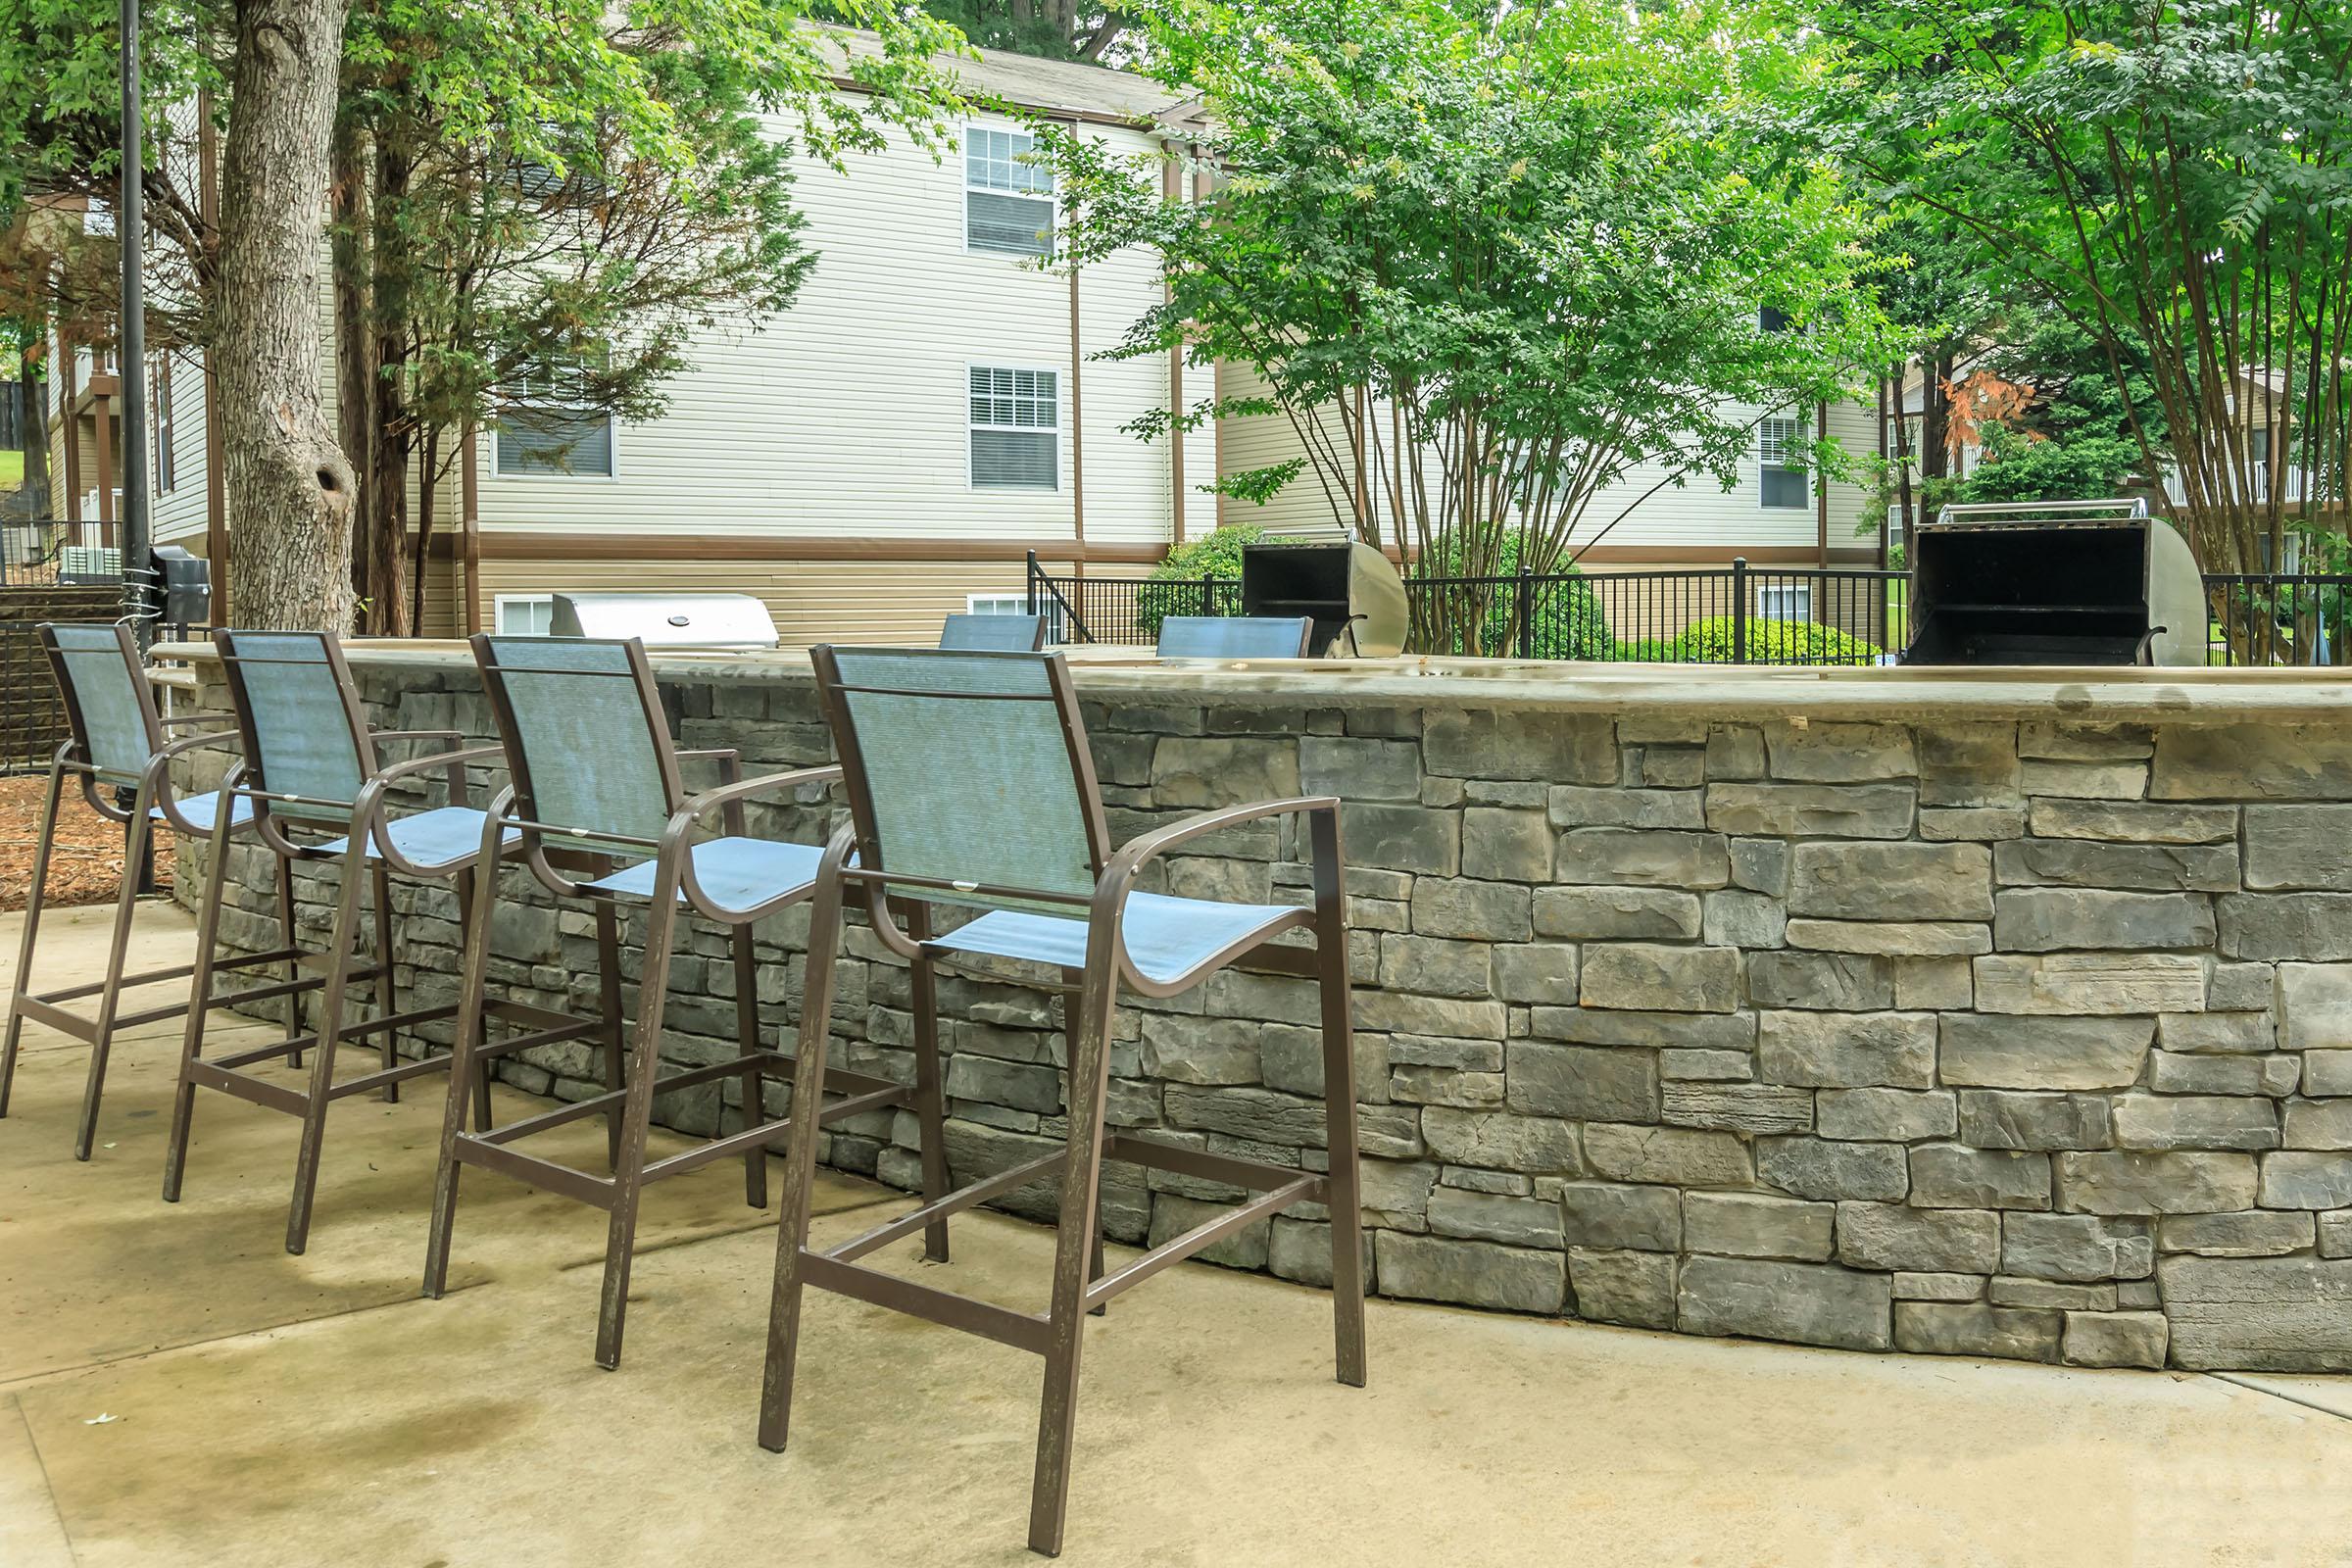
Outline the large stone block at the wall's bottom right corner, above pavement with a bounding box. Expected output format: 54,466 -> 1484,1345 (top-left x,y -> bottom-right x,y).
2157,1255 -> 2352,1373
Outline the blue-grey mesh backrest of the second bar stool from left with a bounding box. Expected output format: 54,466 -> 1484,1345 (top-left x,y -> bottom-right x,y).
212,630 -> 376,823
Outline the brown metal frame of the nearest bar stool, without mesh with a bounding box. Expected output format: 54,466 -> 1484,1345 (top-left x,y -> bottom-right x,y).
760,647 -> 1364,1556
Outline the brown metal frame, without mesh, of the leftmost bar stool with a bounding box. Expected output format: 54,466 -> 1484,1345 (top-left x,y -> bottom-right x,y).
0,625 -> 324,1159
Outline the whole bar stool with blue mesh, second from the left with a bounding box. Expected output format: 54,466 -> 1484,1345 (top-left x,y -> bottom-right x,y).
163,630 -> 595,1253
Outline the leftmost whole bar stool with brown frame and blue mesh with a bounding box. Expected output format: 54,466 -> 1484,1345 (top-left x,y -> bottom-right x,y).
0,625 -> 322,1159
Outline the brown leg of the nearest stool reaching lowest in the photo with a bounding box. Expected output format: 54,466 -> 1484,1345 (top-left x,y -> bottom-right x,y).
1028,958 -> 1117,1556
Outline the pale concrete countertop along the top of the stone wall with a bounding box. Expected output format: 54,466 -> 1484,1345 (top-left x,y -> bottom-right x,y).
155,639 -> 2352,724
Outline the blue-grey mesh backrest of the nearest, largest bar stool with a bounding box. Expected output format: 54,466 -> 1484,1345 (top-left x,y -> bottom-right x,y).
811,647 -> 1107,914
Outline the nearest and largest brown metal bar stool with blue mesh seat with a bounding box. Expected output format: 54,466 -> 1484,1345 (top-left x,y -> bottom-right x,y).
760,647 -> 1364,1556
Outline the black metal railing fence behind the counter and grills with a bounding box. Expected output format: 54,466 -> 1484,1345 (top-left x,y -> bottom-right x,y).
1028,555 -> 2352,665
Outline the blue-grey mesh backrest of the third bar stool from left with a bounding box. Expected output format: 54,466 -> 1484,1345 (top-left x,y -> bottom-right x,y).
472,635 -> 682,856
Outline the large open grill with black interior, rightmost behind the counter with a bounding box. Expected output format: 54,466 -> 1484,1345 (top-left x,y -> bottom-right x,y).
1903,501 -> 2206,665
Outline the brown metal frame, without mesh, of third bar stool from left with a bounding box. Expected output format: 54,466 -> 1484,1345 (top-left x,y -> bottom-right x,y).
423,635 -> 946,1368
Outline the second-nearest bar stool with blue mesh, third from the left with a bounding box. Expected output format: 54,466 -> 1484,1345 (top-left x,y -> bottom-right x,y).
425,635 -> 946,1368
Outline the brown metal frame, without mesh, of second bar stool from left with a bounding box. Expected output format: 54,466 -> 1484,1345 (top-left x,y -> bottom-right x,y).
163,630 -> 595,1253
